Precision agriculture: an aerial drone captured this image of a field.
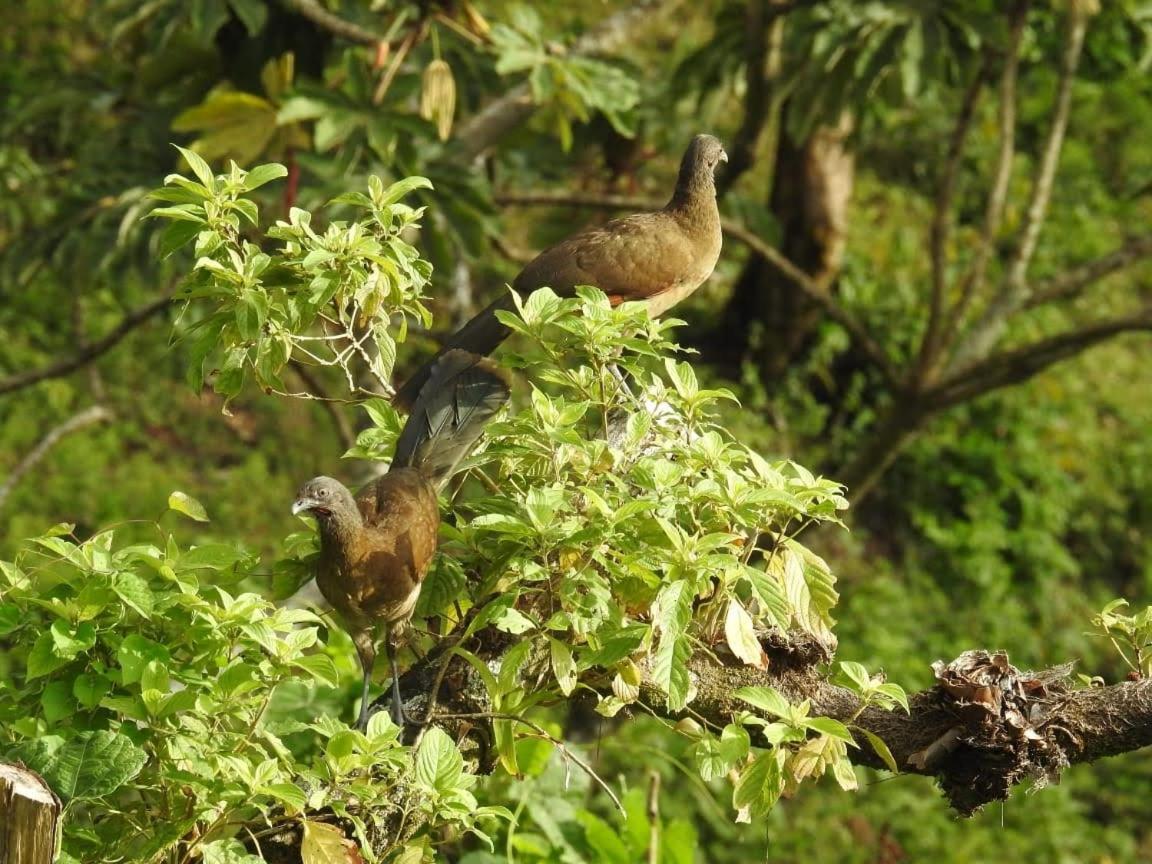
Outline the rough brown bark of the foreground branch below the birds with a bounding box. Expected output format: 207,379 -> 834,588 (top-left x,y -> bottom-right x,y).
391,628 -> 1152,814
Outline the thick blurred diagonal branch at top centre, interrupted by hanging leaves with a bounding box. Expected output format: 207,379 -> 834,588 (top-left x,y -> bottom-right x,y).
452,0 -> 676,164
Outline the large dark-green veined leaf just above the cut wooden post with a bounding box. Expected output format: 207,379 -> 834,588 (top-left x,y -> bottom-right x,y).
17,729 -> 147,801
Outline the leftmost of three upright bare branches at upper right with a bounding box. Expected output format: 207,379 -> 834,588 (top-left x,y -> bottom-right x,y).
918,50 -> 992,378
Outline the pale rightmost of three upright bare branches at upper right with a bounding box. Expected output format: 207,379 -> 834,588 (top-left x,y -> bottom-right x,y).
957,5 -> 1089,363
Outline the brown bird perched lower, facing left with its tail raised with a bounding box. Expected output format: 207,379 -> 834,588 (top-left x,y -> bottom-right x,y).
291,350 -> 508,729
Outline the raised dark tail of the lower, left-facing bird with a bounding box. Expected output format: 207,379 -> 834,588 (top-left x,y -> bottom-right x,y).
392,348 -> 509,487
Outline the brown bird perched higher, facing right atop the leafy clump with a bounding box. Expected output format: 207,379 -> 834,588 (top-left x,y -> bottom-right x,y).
393,135 -> 728,408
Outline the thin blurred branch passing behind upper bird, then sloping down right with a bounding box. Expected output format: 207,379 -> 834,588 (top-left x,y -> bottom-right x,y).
493,192 -> 901,385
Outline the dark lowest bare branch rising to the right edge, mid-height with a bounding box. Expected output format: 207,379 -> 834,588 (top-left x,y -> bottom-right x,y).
925,306 -> 1152,410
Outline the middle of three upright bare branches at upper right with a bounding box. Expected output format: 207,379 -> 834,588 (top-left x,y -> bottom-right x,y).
945,0 -> 1030,347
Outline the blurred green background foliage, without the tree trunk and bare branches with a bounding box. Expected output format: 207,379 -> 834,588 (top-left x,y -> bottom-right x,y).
0,0 -> 1152,863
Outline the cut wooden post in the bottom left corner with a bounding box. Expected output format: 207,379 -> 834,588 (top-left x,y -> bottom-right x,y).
0,764 -> 61,864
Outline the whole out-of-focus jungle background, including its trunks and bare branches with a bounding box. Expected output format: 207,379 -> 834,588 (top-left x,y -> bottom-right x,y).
0,0 -> 1152,864
